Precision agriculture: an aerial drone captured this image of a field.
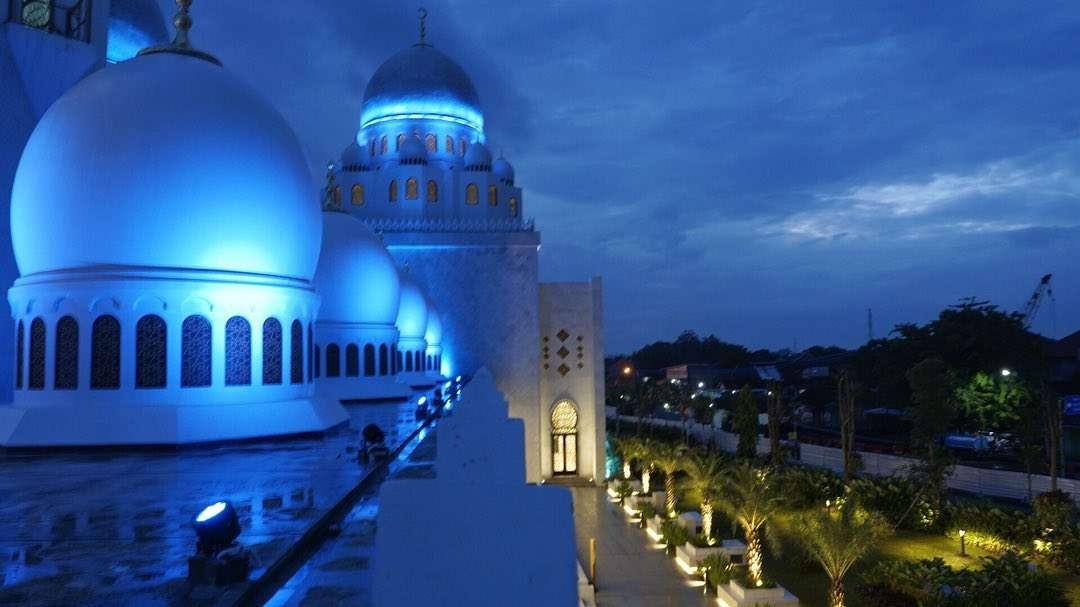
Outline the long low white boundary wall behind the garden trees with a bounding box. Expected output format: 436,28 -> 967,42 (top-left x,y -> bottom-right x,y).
619,415 -> 1080,502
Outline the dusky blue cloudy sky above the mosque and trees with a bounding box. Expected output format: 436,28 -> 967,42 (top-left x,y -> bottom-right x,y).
172,0 -> 1080,354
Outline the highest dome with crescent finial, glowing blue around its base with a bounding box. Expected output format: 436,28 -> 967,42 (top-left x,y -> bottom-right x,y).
360,44 -> 484,131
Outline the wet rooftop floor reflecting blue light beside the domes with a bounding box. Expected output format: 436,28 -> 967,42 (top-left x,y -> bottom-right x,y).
0,402 -> 417,605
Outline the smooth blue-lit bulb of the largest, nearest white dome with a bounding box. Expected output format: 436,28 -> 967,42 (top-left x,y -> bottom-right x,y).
11,52 -> 321,280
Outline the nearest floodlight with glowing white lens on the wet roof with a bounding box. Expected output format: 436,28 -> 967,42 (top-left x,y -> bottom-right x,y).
188,500 -> 252,585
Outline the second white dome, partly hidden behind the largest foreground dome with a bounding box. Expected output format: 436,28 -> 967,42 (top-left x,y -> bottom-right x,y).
315,211 -> 401,325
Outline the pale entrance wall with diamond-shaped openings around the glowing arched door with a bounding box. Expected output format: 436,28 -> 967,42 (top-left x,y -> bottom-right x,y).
538,278 -> 605,480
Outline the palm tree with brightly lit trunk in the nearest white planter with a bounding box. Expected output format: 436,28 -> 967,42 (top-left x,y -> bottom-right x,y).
717,462 -> 781,585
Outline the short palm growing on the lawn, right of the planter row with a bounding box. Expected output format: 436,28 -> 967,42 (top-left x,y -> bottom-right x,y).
799,508 -> 892,607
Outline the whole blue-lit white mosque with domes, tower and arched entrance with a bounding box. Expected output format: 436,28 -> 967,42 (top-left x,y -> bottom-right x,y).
0,0 -> 605,482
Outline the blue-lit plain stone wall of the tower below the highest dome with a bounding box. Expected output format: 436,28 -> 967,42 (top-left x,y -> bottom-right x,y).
384,232 -> 541,483
